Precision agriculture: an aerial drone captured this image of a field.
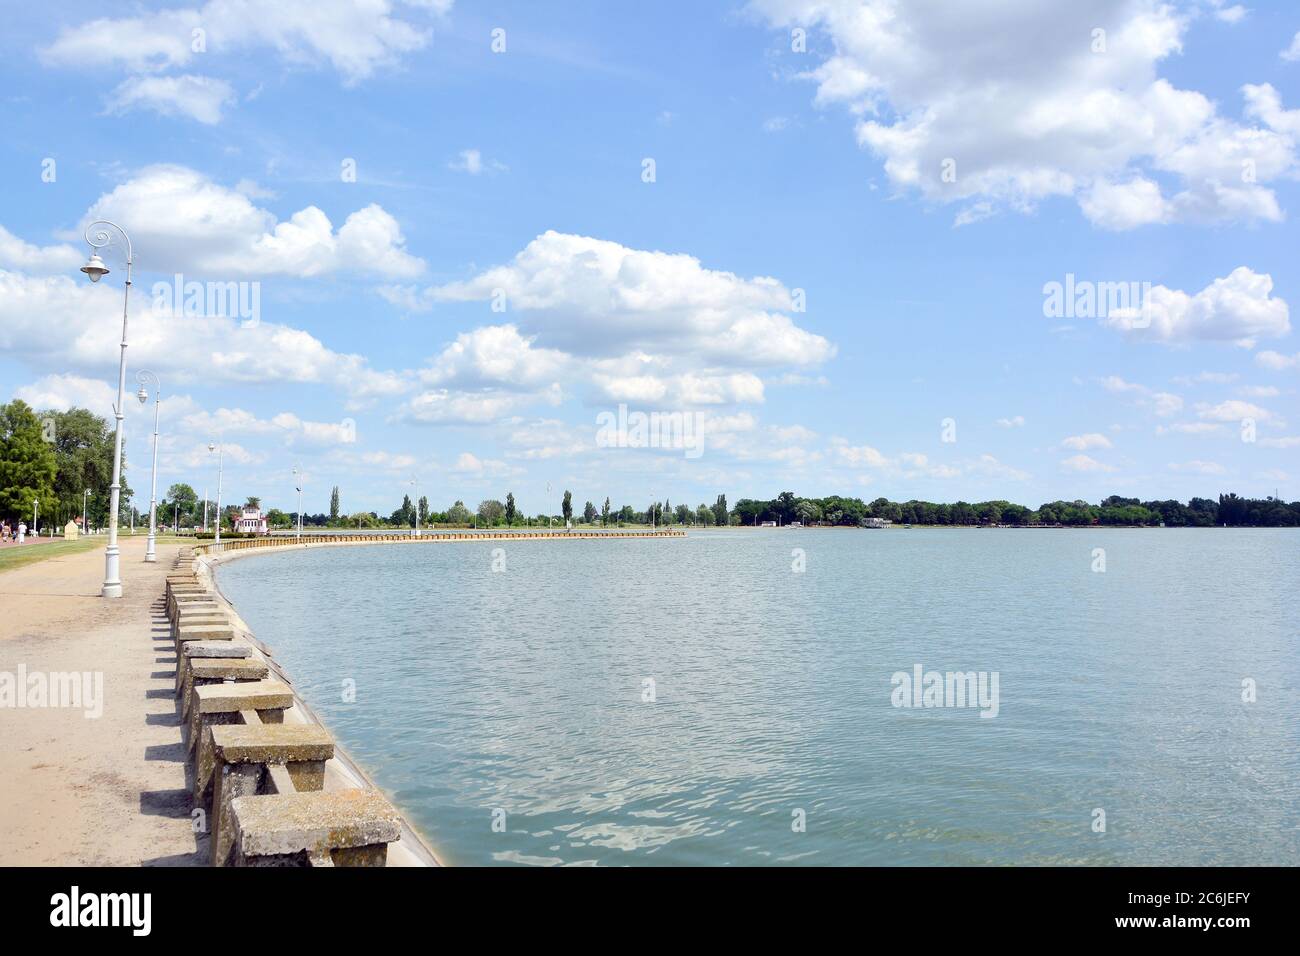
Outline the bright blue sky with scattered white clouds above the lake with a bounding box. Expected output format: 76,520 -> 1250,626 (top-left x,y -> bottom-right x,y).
0,0 -> 1300,514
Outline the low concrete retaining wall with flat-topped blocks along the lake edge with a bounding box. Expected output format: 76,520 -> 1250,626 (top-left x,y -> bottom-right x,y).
161,540 -> 437,866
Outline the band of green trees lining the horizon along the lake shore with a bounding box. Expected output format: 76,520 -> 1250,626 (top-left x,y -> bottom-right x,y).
0,399 -> 1300,536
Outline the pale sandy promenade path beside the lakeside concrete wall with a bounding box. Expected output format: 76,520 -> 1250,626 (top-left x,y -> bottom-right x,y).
0,536 -> 207,866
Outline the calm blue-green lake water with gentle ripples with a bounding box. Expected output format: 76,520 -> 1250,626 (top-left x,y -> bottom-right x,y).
218,528 -> 1300,865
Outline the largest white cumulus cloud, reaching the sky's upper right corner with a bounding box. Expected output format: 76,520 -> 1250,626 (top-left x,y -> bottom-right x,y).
750,0 -> 1297,229
